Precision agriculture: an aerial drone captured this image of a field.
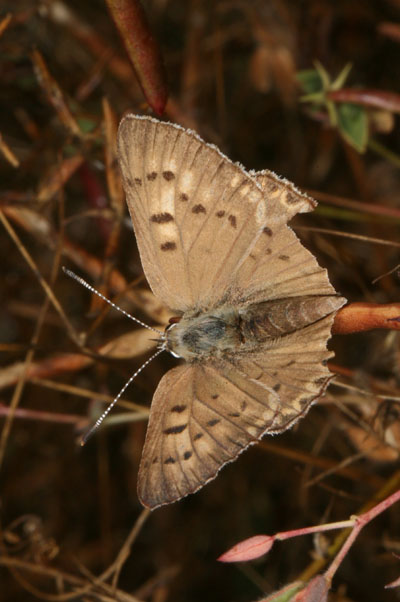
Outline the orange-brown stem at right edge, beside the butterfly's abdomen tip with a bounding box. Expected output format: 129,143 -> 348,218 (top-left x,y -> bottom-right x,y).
332,303 -> 400,334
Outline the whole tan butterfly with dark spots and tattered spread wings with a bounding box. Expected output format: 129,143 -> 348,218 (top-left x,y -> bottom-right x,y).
118,115 -> 346,509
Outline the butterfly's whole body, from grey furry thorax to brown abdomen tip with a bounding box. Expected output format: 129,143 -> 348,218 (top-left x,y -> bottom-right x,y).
166,295 -> 341,362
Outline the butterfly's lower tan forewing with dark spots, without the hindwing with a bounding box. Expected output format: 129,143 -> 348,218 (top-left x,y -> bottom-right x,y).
138,362 -> 279,508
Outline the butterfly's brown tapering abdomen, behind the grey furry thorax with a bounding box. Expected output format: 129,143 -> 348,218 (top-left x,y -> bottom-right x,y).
239,295 -> 342,344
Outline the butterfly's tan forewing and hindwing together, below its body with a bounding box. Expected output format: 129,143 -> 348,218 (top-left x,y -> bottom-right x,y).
138,314 -> 333,509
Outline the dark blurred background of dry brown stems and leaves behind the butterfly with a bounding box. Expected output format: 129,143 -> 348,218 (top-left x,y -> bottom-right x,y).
0,0 -> 400,602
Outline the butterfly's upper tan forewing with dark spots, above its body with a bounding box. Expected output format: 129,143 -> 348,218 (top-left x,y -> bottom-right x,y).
118,115 -> 266,311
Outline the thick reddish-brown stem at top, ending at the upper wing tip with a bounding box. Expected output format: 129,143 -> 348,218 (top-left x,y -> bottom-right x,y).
106,0 -> 168,115
